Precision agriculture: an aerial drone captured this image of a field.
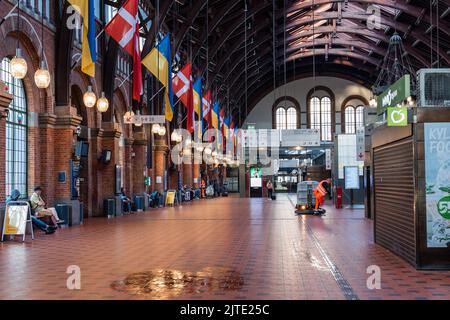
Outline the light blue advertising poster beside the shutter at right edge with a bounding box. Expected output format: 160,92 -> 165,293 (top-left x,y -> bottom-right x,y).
425,123 -> 450,248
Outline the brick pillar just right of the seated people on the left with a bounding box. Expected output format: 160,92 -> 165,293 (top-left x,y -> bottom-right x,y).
53,106 -> 82,204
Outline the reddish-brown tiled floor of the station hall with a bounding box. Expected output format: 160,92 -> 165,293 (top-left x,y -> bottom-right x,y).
0,195 -> 450,299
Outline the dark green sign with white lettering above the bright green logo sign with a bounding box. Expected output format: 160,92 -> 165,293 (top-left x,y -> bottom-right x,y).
377,74 -> 411,114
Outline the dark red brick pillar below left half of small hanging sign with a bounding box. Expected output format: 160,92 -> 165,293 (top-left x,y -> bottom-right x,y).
133,131 -> 147,194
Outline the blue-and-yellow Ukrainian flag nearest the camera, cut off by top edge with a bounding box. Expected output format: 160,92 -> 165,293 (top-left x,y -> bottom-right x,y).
69,0 -> 97,77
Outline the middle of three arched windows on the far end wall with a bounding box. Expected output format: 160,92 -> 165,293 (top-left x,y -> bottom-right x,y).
309,96 -> 333,141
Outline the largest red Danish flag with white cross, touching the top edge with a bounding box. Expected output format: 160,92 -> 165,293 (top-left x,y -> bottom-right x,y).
105,0 -> 143,102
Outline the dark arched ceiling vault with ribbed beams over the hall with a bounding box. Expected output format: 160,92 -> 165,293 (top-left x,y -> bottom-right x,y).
108,0 -> 450,125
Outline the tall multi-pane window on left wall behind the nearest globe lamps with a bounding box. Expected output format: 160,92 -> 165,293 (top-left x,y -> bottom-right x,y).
0,58 -> 28,196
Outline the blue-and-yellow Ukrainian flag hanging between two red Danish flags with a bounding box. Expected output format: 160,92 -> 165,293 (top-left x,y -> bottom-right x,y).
142,33 -> 173,121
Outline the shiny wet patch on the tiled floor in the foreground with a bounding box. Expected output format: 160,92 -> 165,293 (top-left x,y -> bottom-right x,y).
111,268 -> 244,299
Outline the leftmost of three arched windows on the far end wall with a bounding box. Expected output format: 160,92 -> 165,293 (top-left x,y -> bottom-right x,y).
273,97 -> 300,130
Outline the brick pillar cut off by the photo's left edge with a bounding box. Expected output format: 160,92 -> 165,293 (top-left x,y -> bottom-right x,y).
0,81 -> 13,205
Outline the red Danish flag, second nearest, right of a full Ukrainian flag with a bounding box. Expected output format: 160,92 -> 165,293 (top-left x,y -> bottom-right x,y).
172,63 -> 195,133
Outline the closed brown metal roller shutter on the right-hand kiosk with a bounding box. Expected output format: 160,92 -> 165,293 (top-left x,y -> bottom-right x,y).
373,138 -> 416,265
